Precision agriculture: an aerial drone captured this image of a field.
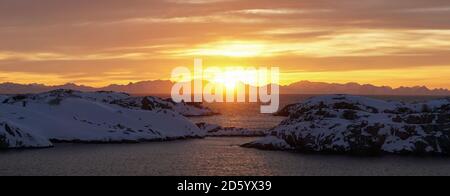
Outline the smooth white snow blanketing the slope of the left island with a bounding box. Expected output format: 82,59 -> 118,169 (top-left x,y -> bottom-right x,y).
0,90 -> 205,149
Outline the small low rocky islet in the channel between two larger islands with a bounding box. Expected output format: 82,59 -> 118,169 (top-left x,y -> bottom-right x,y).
197,123 -> 267,137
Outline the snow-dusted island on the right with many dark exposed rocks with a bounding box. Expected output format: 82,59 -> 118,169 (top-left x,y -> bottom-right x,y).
243,95 -> 450,156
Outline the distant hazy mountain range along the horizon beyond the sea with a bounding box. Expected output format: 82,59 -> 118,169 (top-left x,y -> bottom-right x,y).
0,80 -> 450,96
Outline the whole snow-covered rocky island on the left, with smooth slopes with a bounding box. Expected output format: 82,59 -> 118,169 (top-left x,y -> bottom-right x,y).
0,90 -> 213,149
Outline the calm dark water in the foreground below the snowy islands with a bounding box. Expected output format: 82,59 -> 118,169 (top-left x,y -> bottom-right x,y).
0,138 -> 450,176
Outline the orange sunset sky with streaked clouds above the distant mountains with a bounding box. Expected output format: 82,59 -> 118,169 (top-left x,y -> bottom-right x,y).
0,0 -> 450,88
